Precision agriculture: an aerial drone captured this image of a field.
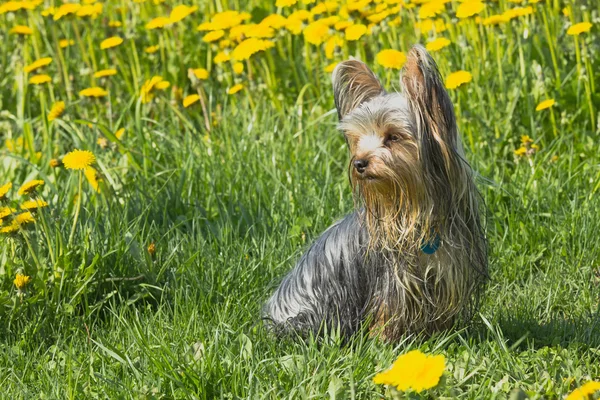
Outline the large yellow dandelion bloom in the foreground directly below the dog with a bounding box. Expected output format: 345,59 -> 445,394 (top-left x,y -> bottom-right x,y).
373,350 -> 446,393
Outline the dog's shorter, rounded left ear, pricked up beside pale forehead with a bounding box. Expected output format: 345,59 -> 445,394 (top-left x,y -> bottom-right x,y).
332,60 -> 385,120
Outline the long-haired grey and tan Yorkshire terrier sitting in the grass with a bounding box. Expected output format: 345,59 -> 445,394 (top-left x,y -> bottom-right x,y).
263,46 -> 488,340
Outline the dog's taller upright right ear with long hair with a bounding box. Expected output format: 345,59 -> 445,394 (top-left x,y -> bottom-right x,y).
402,45 -> 457,148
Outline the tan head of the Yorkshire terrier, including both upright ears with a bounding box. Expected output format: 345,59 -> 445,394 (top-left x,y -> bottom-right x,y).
333,46 -> 466,227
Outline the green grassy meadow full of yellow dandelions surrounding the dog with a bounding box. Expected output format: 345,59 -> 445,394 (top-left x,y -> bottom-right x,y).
0,0 -> 600,399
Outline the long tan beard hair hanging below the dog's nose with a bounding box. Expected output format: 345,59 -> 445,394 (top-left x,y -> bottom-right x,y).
352,159 -> 434,255
